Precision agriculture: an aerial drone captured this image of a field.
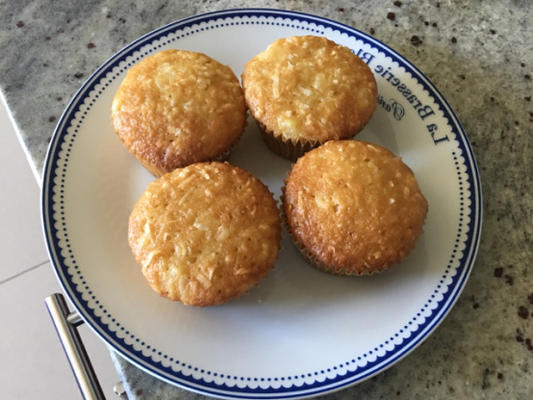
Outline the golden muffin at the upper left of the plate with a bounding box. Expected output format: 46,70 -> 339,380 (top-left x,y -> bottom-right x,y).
111,50 -> 246,176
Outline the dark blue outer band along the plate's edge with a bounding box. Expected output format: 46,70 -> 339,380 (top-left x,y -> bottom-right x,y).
41,8 -> 482,399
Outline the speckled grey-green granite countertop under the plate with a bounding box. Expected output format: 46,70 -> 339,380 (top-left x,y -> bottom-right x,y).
0,0 -> 533,399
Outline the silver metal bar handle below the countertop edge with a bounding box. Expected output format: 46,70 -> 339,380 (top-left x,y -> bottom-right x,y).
44,293 -> 105,400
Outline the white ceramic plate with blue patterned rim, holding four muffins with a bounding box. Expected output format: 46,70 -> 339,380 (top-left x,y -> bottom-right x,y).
42,9 -> 481,398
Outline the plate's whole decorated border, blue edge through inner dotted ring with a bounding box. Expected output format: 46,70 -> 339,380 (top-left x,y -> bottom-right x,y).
43,10 -> 481,398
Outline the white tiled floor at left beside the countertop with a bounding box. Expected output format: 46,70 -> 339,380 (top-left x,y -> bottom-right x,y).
0,94 -> 119,400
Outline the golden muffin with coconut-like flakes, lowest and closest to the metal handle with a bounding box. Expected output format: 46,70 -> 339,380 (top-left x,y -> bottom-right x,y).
128,162 -> 280,306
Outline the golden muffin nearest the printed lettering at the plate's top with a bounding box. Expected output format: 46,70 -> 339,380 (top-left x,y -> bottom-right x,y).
242,36 -> 377,161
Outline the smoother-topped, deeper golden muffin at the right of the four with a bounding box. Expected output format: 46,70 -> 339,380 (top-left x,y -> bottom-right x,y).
283,140 -> 428,275
